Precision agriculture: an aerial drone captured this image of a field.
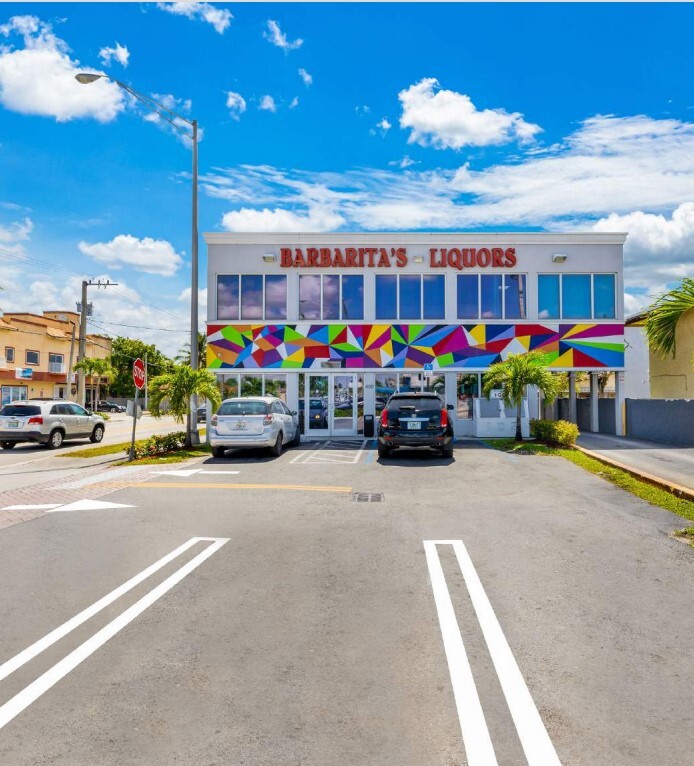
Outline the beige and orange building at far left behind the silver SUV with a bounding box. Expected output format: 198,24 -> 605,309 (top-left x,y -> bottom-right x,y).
0,311 -> 111,404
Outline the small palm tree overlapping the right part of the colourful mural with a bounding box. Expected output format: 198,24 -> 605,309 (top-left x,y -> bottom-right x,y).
482,351 -> 559,441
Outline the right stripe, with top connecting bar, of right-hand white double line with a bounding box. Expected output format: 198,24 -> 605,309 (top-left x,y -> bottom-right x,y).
433,540 -> 561,766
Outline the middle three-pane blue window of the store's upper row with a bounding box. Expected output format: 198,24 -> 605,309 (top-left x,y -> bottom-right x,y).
376,274 -> 446,319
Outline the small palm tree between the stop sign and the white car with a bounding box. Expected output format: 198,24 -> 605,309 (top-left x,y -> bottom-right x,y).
149,364 -> 222,447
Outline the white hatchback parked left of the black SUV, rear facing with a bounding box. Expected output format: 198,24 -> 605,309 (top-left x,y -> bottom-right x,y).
210,396 -> 301,457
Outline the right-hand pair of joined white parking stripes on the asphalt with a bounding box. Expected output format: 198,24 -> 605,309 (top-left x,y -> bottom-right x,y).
424,540 -> 561,766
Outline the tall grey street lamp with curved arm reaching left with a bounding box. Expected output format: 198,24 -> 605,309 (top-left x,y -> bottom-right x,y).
75,72 -> 200,445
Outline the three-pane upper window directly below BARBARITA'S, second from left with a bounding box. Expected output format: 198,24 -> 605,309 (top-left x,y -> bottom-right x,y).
299,274 -> 364,319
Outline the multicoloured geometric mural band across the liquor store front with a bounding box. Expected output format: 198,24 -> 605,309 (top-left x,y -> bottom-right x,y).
207,323 -> 624,370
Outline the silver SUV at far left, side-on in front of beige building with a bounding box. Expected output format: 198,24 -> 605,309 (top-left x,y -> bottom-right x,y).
0,399 -> 105,449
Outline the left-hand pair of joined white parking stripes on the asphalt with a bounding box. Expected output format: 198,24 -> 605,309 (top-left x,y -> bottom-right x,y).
0,537 -> 229,729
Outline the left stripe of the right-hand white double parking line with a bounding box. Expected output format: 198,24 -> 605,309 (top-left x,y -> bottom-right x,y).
424,540 -> 498,766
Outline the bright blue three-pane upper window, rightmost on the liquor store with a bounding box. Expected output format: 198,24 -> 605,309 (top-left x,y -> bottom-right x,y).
537,274 -> 616,319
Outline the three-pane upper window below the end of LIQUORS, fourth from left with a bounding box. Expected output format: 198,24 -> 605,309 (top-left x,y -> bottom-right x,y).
457,274 -> 527,319
